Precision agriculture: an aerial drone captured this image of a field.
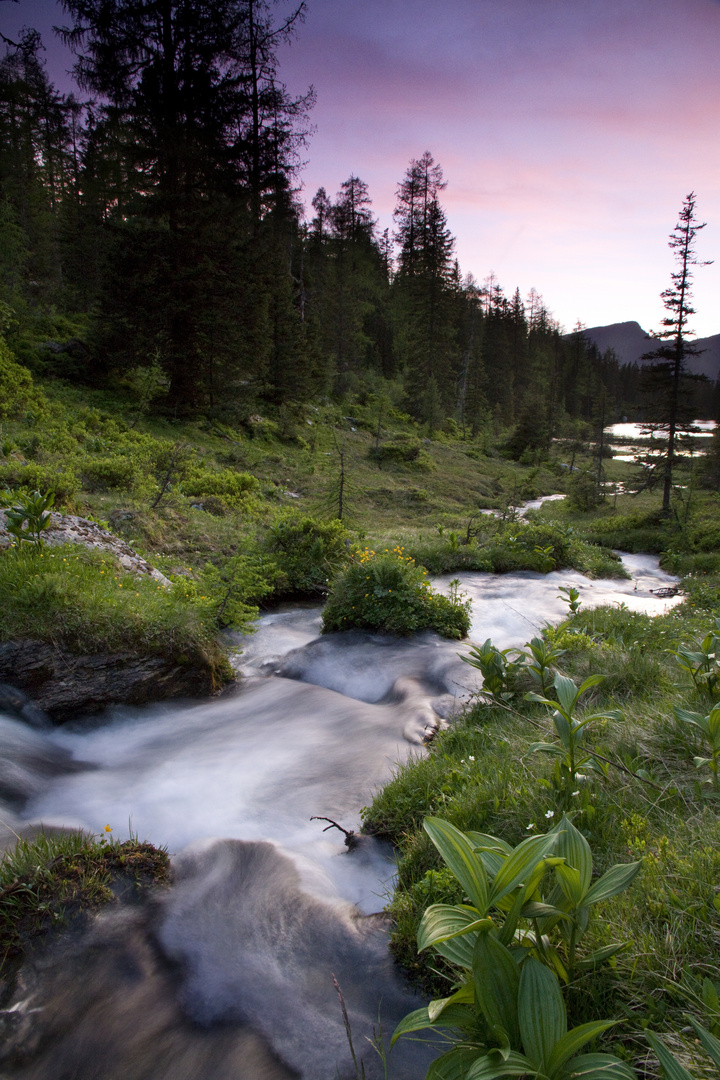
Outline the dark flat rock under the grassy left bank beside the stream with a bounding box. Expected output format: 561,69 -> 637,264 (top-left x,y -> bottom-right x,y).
0,640 -> 221,724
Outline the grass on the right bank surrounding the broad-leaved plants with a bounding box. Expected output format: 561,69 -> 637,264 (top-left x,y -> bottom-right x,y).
364,594 -> 720,1077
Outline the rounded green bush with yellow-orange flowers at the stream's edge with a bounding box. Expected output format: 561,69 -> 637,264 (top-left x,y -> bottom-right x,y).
323,548 -> 470,639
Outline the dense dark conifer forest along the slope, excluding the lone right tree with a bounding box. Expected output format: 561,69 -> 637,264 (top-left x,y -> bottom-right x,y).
0,0 -> 708,455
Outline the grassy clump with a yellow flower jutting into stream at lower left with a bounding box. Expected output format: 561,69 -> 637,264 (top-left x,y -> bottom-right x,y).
0,831 -> 169,972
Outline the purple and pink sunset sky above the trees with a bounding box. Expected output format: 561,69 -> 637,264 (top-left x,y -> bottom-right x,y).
0,0 -> 720,337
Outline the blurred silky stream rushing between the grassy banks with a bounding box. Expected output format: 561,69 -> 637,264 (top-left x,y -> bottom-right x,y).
0,555 -> 673,1080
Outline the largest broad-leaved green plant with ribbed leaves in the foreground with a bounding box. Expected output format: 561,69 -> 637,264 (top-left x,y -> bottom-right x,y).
393,815 -> 640,1080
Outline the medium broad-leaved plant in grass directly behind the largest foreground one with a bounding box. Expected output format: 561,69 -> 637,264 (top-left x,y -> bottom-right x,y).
526,672 -> 621,797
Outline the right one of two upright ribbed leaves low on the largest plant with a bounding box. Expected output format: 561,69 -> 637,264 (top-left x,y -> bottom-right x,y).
517,957 -> 568,1069
